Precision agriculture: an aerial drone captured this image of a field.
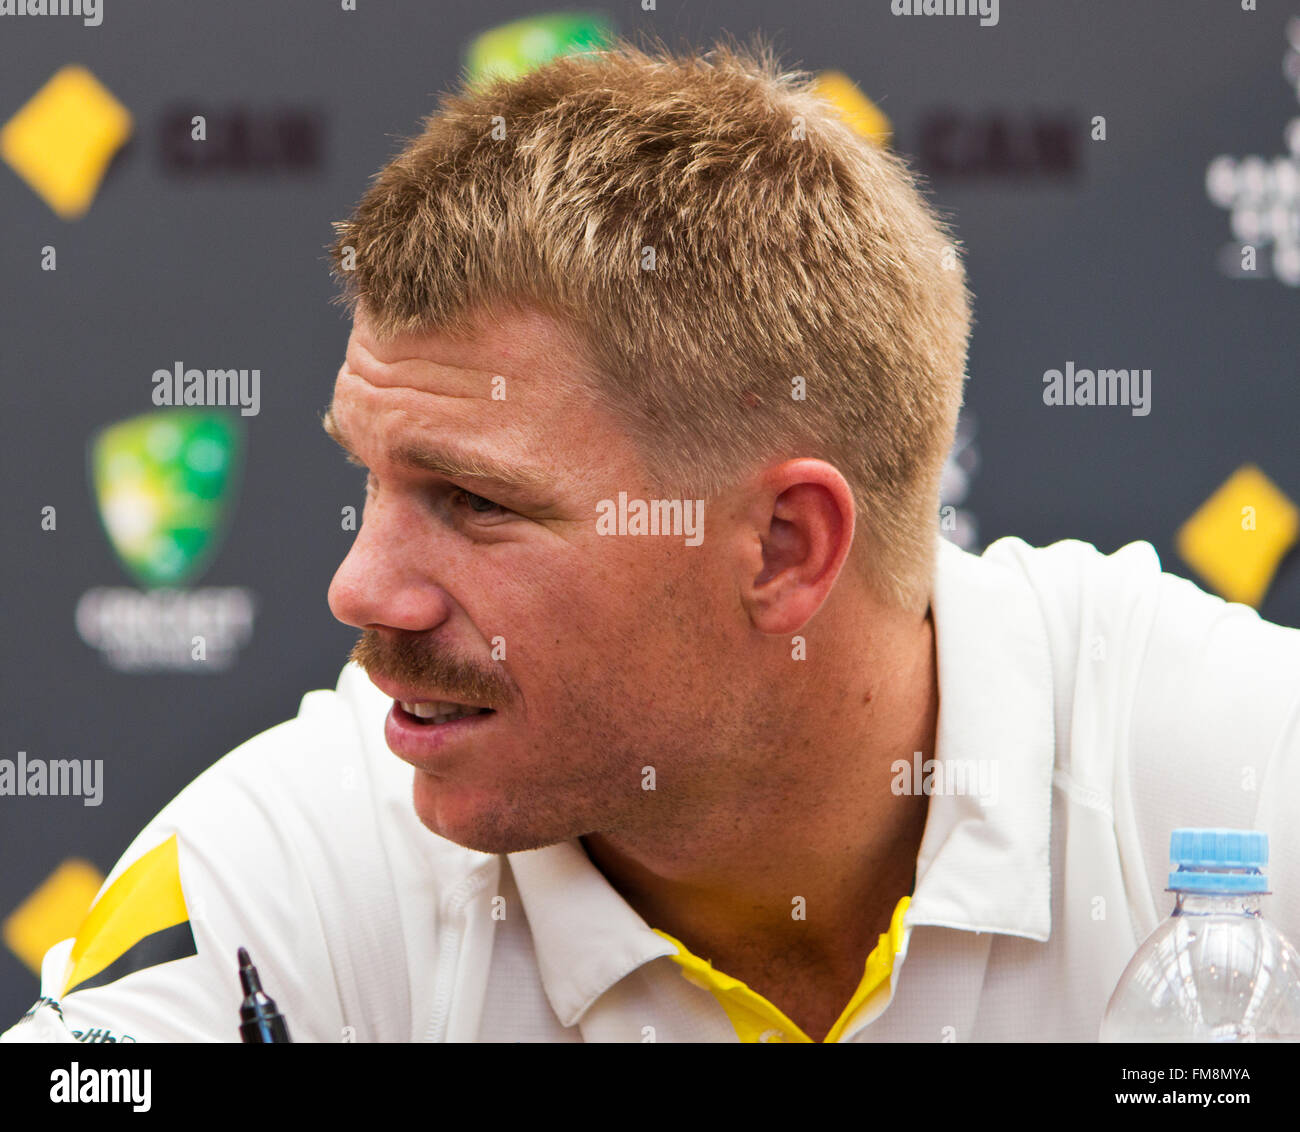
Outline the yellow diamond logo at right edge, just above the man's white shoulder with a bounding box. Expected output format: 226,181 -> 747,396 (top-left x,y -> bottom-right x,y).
1174,464 -> 1300,606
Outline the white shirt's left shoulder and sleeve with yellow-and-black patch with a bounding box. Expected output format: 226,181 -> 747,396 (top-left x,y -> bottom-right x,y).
0,665 -> 491,1041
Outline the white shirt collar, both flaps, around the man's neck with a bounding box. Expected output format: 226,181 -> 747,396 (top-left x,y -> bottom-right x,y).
507,538 -> 1056,1025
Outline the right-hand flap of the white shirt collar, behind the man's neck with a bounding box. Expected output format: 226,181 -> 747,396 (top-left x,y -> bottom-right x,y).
906,538 -> 1056,941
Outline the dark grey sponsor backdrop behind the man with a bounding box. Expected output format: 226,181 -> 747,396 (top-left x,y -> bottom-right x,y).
0,0 -> 1300,1028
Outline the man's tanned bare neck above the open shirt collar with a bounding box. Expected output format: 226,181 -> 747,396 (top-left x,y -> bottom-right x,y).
582,615 -> 939,1028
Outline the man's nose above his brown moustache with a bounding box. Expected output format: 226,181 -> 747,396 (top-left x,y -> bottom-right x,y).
329,500 -> 449,633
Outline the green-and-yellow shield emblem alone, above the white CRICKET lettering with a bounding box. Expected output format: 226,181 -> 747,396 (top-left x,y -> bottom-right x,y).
90,408 -> 241,589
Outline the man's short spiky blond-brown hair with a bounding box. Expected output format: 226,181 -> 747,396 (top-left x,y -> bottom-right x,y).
332,40 -> 971,612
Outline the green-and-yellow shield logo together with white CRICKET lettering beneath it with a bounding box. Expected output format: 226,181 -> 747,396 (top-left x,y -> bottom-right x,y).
77,408 -> 254,672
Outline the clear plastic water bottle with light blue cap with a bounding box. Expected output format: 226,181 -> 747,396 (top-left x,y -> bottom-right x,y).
1101,829 -> 1300,1042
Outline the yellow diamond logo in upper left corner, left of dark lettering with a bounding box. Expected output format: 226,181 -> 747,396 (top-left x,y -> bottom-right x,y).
0,65 -> 131,220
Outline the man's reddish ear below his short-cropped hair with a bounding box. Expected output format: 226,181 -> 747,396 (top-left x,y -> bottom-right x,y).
740,459 -> 855,636
